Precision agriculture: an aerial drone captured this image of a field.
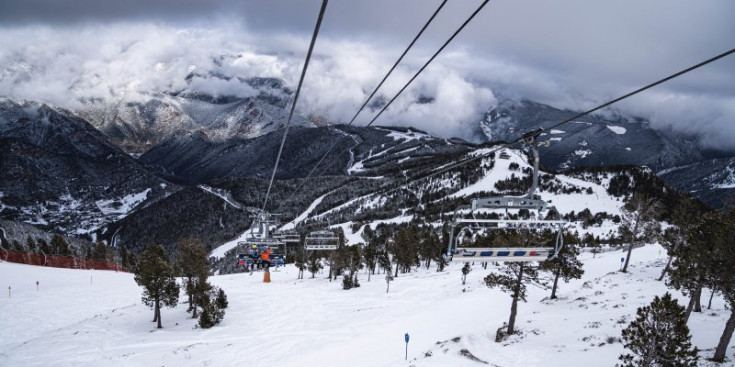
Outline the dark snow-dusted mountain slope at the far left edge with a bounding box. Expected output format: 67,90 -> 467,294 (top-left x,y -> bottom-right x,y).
0,99 -> 175,234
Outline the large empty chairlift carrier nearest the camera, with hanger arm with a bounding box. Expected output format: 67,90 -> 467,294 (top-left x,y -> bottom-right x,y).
446,129 -> 566,262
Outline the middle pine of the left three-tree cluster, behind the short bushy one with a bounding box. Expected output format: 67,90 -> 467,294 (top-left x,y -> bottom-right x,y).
176,238 -> 210,318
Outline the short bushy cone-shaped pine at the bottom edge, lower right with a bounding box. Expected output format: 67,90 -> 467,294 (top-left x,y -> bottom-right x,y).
618,293 -> 699,367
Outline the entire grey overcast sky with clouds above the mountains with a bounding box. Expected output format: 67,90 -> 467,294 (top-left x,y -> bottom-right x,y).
0,0 -> 735,149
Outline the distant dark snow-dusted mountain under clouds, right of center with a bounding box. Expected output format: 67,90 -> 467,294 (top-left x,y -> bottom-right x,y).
480,100 -> 704,170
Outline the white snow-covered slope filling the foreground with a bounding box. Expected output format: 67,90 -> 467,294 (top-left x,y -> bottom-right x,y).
0,245 -> 735,367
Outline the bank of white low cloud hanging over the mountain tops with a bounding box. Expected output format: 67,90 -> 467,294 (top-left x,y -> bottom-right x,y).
0,18 -> 735,149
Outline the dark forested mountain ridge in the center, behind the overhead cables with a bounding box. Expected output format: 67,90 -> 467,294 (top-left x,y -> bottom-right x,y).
140,125 -> 470,184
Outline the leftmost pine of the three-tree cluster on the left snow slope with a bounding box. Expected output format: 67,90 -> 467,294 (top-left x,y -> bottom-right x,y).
135,245 -> 179,329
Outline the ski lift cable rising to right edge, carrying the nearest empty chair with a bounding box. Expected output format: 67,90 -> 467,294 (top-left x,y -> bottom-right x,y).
376,48 -> 735,200
